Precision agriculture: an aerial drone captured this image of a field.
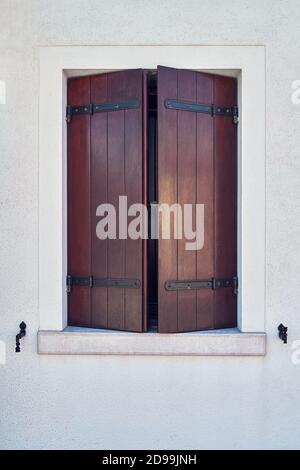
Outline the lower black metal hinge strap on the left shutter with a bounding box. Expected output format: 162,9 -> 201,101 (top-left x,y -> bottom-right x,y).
67,275 -> 141,292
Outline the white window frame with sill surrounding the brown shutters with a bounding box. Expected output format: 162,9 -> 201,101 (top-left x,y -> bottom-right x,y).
38,46 -> 266,354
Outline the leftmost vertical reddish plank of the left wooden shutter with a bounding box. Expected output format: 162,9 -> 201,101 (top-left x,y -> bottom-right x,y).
68,77 -> 91,326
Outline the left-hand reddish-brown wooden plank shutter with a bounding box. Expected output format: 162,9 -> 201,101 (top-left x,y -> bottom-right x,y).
68,70 -> 146,331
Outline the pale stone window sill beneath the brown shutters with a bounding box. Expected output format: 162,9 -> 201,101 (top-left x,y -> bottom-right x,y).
38,327 -> 266,356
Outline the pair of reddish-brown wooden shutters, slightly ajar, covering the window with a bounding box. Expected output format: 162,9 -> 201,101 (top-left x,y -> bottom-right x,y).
68,67 -> 237,333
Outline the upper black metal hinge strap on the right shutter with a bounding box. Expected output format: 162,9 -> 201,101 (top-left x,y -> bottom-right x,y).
165,99 -> 239,124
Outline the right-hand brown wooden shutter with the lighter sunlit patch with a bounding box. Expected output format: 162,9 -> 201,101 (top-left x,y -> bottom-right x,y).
158,67 -> 237,332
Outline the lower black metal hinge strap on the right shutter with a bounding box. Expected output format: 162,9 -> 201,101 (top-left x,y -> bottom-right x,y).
165,277 -> 238,294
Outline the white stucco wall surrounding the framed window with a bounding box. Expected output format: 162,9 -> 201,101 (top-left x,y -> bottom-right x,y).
0,0 -> 300,449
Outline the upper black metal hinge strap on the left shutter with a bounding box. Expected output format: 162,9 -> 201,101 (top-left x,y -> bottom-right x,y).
66,99 -> 140,122
